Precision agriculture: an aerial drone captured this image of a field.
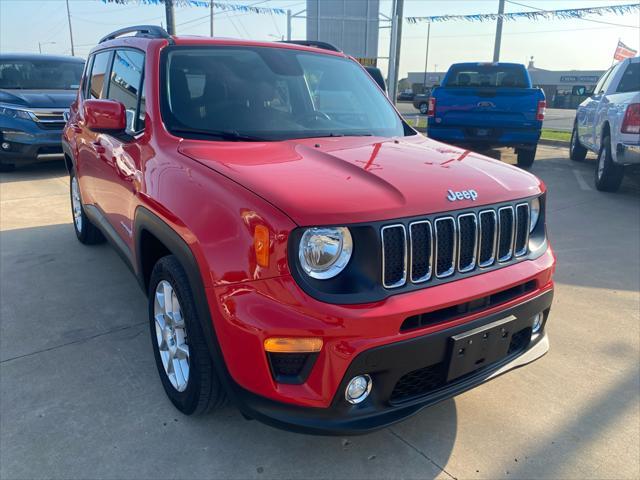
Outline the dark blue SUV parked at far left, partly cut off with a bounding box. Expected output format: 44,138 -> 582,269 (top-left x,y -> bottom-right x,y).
0,53 -> 84,171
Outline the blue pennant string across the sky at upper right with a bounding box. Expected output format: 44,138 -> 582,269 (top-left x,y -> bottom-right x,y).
407,3 -> 640,23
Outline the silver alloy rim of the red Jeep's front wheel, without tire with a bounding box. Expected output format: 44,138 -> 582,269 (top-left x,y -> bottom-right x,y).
153,280 -> 189,392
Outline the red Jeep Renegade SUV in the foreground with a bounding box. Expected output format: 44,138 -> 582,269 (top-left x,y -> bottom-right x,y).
64,26 -> 555,433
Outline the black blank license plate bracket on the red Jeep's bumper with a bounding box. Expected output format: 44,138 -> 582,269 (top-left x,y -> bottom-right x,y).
447,315 -> 516,382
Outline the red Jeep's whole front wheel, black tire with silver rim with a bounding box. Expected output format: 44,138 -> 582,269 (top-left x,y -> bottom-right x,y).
149,255 -> 225,415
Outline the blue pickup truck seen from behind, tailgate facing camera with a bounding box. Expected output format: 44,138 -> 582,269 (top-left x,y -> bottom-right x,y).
427,63 -> 546,168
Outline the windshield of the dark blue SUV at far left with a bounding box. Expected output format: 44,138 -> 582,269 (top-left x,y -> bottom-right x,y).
0,59 -> 84,90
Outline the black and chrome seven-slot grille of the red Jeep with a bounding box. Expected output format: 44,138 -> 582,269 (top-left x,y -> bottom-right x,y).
381,202 -> 529,288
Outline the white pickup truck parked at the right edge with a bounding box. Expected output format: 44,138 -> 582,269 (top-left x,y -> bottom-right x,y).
569,57 -> 640,192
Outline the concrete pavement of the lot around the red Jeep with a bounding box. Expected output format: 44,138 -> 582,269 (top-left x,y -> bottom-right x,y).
0,146 -> 640,479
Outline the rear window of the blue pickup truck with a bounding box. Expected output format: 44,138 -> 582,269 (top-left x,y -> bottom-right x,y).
444,64 -> 529,88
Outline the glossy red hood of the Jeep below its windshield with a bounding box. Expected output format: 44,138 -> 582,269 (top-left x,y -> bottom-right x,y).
178,135 -> 544,226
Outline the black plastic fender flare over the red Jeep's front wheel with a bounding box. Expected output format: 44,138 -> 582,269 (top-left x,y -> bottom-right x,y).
134,207 -> 238,404
